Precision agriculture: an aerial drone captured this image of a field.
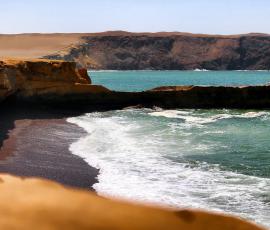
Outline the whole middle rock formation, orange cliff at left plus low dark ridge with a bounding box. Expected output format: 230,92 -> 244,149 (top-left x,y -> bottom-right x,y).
0,60 -> 270,110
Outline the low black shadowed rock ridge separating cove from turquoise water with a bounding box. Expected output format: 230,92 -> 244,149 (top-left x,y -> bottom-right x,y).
17,83 -> 270,111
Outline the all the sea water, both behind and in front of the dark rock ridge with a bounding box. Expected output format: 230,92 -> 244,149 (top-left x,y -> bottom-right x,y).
68,71 -> 270,227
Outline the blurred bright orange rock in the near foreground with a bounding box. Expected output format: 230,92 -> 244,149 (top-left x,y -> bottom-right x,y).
0,175 -> 261,230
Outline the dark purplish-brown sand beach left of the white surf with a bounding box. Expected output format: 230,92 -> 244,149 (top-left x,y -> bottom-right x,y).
0,104 -> 98,189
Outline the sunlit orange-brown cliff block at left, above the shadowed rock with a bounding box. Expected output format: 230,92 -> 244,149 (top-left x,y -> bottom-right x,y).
0,59 -> 108,100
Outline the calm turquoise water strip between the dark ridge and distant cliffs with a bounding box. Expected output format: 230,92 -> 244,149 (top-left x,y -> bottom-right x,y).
89,71 -> 270,91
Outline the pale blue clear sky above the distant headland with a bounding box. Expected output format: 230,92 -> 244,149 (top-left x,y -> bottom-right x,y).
0,0 -> 270,34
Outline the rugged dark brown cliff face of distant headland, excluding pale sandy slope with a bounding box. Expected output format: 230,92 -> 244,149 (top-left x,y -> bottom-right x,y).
46,33 -> 270,70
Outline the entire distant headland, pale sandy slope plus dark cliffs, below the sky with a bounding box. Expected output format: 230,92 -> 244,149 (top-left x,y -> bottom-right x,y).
0,31 -> 270,70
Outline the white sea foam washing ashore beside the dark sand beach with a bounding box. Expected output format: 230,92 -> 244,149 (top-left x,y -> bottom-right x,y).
68,110 -> 270,226
